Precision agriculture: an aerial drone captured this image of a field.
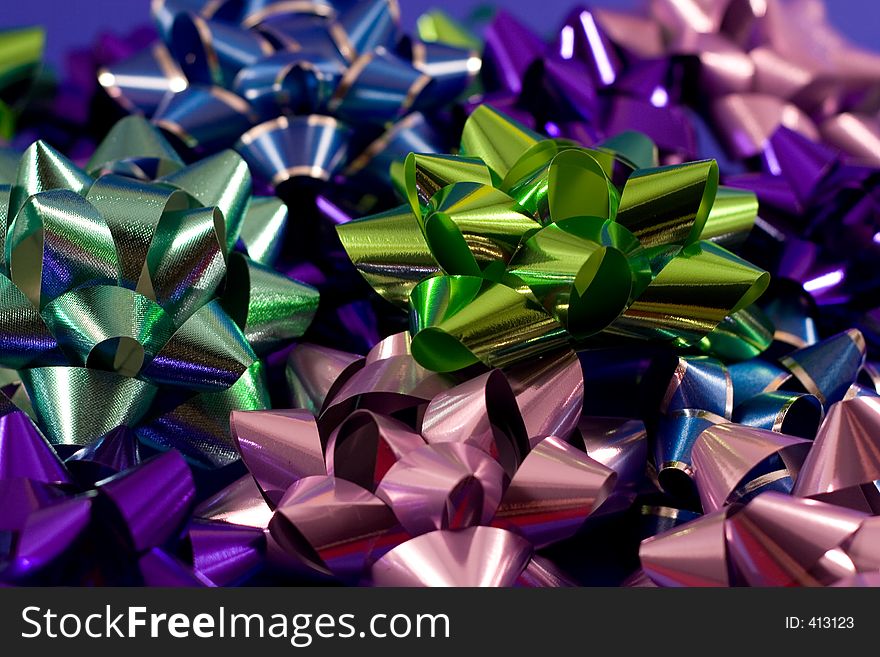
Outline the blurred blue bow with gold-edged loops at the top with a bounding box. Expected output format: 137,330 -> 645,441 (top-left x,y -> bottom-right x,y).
99,0 -> 480,190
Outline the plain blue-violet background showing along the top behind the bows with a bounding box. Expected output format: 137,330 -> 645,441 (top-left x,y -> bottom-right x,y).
0,0 -> 880,64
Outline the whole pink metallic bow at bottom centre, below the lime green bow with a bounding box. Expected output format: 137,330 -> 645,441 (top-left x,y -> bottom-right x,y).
196,334 -> 647,586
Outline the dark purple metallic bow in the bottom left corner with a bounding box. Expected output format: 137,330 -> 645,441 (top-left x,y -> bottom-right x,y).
0,402 -> 212,586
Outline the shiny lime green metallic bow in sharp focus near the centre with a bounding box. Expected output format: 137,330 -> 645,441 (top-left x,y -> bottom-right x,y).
337,105 -> 770,371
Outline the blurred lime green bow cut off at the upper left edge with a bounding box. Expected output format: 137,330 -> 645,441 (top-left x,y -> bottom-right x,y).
0,27 -> 46,139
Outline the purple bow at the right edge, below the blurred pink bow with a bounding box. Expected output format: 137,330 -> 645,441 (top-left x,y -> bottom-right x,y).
728,127 -> 880,316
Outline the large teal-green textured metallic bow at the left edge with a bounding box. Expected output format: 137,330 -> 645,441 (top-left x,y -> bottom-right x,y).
0,117 -> 318,466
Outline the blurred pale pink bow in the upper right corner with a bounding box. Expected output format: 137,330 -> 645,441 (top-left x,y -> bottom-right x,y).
632,0 -> 880,165
